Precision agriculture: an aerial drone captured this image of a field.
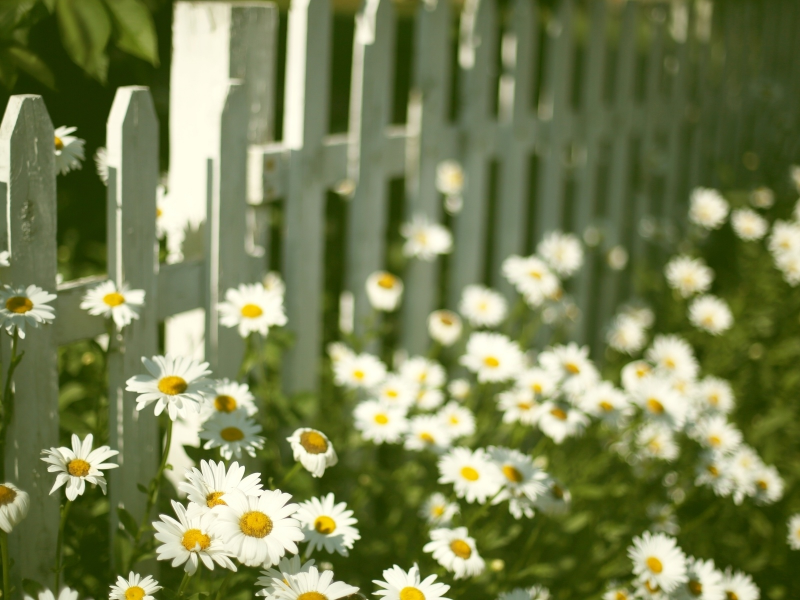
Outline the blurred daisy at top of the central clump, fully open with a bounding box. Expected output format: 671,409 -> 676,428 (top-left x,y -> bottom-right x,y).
459,332 -> 524,383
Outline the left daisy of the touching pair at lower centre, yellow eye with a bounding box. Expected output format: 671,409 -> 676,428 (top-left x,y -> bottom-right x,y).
438,447 -> 503,504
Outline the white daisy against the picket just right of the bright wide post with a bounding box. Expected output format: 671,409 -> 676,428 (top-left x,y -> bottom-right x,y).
217,283 -> 286,337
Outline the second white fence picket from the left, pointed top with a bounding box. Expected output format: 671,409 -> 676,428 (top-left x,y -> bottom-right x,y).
106,86 -> 160,560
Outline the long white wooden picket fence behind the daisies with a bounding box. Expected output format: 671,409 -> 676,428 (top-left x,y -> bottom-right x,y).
0,0 -> 792,581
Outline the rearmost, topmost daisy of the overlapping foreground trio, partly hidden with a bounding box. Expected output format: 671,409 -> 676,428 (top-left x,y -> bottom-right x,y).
178,460 -> 261,508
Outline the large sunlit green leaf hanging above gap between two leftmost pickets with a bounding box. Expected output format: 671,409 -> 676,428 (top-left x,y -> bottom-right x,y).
56,0 -> 111,83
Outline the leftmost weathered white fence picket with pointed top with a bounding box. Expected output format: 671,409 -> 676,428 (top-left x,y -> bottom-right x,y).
0,95 -> 59,590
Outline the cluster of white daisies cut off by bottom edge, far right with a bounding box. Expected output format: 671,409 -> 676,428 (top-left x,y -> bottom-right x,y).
603,531 -> 760,600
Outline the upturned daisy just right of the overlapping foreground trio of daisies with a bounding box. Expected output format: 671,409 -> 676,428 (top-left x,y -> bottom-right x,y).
294,494 -> 361,556
